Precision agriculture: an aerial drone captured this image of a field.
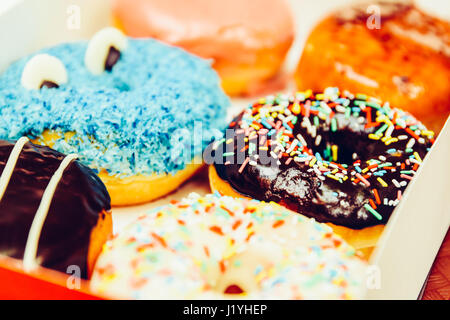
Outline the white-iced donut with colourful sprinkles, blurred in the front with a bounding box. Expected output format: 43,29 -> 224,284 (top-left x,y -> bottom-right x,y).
91,194 -> 366,299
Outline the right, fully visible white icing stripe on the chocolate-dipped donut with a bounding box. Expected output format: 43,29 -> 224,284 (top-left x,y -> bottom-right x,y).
23,154 -> 78,271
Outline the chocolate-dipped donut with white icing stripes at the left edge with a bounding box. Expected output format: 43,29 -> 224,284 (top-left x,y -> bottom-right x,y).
0,138 -> 112,278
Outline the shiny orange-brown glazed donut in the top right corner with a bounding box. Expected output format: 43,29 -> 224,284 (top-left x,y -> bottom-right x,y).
295,1 -> 450,132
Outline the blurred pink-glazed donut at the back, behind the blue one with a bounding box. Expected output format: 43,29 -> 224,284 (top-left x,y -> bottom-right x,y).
113,0 -> 294,95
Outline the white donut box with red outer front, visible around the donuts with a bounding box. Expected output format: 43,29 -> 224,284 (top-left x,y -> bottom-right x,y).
0,0 -> 450,299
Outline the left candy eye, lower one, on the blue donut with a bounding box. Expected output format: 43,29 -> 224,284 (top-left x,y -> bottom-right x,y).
21,54 -> 67,89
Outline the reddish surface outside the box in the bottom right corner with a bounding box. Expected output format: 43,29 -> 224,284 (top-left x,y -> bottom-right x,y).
422,231 -> 450,300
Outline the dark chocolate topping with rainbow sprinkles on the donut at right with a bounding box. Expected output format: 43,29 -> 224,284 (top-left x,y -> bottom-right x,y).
210,88 -> 434,229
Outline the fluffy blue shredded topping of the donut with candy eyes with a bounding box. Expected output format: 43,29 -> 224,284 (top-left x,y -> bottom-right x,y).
0,32 -> 229,202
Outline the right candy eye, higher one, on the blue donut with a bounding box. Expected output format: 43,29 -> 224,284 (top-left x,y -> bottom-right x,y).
84,27 -> 128,75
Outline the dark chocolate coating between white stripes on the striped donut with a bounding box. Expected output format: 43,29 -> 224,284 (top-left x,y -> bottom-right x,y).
0,140 -> 110,278
